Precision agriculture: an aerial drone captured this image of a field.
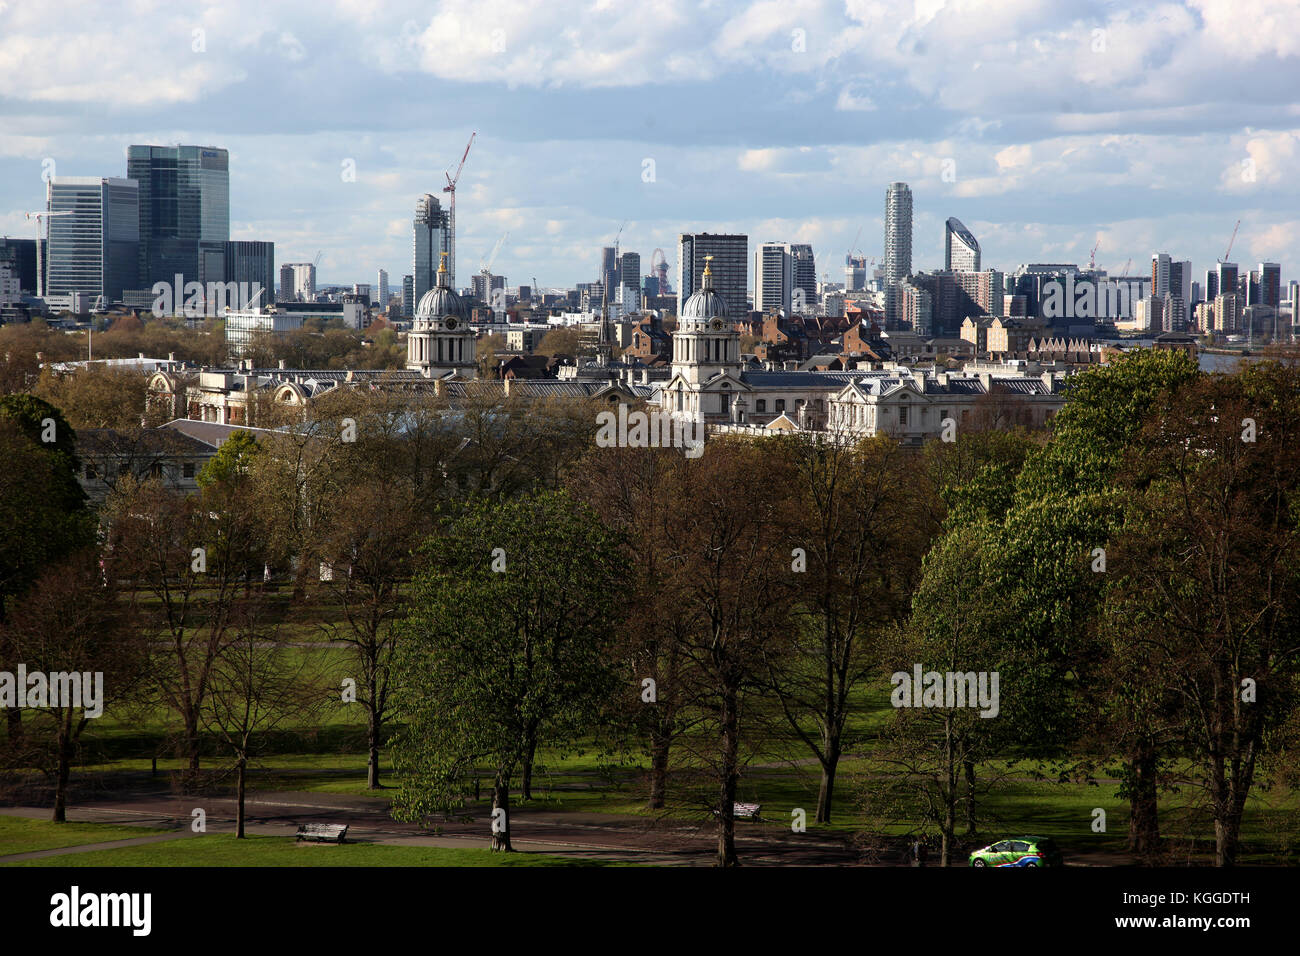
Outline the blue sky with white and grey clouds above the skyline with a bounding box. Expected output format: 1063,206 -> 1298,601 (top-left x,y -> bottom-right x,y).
0,0 -> 1300,289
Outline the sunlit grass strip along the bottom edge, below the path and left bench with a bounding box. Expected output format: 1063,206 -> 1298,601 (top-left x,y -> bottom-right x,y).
12,834 -> 632,868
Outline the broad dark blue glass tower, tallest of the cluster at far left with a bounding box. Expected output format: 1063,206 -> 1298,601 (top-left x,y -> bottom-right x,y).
126,146 -> 230,289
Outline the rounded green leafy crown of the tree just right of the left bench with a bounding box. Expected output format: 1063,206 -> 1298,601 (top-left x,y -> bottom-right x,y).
393,492 -> 625,819
